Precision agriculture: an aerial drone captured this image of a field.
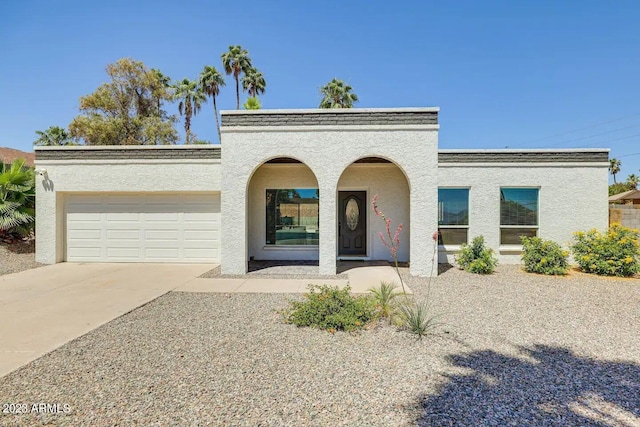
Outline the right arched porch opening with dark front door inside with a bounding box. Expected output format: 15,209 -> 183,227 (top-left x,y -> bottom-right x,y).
336,156 -> 411,270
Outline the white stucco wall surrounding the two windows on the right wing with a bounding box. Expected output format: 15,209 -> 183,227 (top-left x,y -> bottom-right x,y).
438,163 -> 608,264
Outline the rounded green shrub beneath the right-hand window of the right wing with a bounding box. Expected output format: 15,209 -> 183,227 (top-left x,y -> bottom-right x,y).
522,236 -> 569,275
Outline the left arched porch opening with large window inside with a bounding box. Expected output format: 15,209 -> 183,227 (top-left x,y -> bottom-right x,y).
246,157 -> 320,271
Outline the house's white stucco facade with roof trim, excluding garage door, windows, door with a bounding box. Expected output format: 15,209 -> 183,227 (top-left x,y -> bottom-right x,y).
36,108 -> 608,276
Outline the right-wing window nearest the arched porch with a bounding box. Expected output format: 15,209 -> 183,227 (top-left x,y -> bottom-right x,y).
438,188 -> 469,245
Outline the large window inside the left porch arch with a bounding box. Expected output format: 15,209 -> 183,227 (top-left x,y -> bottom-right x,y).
266,189 -> 319,246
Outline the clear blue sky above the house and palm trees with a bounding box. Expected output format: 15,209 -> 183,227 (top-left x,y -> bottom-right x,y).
0,0 -> 640,178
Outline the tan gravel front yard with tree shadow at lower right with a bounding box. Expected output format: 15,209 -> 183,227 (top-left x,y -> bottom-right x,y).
0,266 -> 640,426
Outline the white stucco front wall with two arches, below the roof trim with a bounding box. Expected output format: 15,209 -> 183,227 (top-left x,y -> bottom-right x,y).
222,110 -> 438,276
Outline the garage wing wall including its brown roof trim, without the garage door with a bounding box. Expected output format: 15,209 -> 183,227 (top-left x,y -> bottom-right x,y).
35,145 -> 221,264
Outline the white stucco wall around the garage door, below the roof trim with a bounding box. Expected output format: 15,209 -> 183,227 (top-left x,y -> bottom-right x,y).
36,156 -> 221,264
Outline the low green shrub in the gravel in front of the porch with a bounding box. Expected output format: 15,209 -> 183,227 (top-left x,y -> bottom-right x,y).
283,285 -> 376,333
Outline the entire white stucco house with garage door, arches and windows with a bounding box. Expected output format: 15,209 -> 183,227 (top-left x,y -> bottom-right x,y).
35,108 -> 609,276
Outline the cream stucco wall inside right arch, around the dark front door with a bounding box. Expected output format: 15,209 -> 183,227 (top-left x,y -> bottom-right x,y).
338,163 -> 410,261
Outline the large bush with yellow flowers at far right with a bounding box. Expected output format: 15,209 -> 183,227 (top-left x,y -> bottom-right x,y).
571,224 -> 640,277
